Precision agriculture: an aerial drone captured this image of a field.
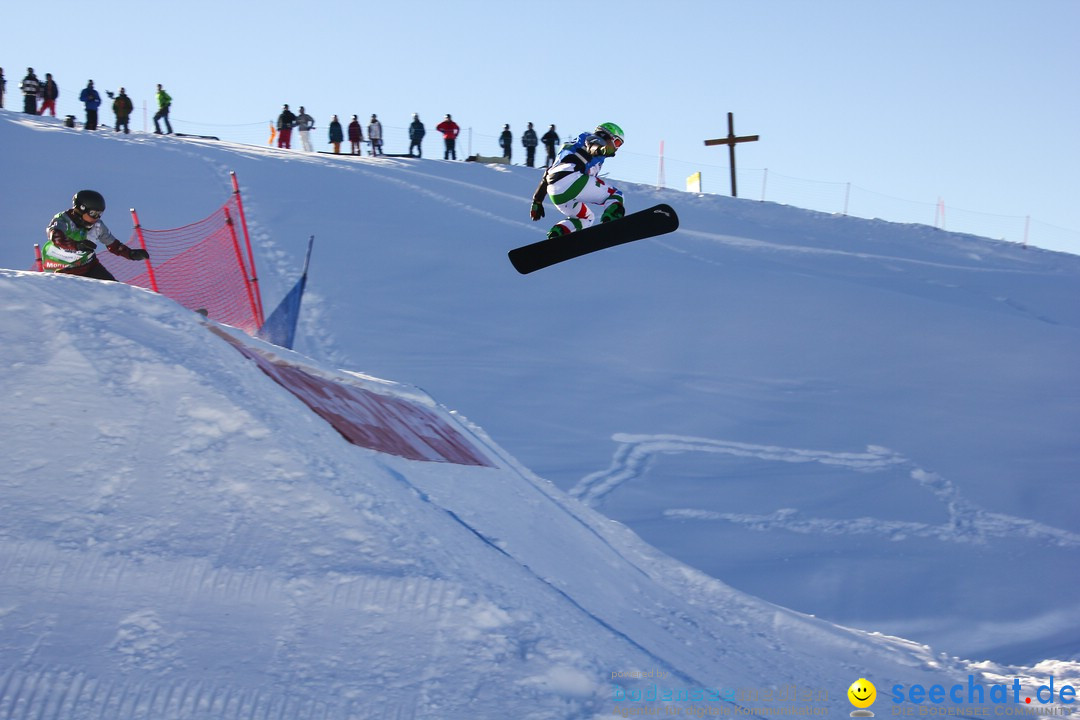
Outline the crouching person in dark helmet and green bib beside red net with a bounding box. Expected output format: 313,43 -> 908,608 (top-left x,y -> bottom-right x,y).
41,190 -> 150,281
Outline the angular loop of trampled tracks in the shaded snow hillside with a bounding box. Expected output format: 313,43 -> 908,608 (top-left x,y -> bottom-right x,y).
570,434 -> 1080,547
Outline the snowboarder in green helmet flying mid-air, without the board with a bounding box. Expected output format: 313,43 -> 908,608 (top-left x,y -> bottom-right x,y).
529,122 -> 625,237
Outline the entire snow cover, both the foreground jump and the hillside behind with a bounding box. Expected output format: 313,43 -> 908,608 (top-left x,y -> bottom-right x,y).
0,112 -> 1080,717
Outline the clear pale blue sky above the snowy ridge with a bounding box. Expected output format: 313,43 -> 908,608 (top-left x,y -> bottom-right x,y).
8,0 -> 1080,253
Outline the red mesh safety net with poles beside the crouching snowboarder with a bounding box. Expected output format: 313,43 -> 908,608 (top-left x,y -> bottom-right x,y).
97,176 -> 262,335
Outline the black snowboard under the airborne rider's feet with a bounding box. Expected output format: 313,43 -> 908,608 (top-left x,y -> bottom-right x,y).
509,205 -> 678,275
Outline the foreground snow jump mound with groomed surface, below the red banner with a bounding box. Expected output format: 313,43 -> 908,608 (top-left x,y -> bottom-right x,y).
0,271 -> 1071,719
